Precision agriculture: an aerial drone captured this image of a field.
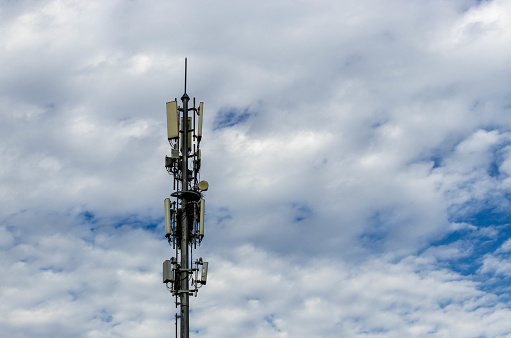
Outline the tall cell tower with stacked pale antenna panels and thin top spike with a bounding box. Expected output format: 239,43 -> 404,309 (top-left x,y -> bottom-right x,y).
163,58 -> 209,338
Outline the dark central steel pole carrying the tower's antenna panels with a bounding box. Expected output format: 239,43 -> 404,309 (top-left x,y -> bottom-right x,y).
180,92 -> 190,338
